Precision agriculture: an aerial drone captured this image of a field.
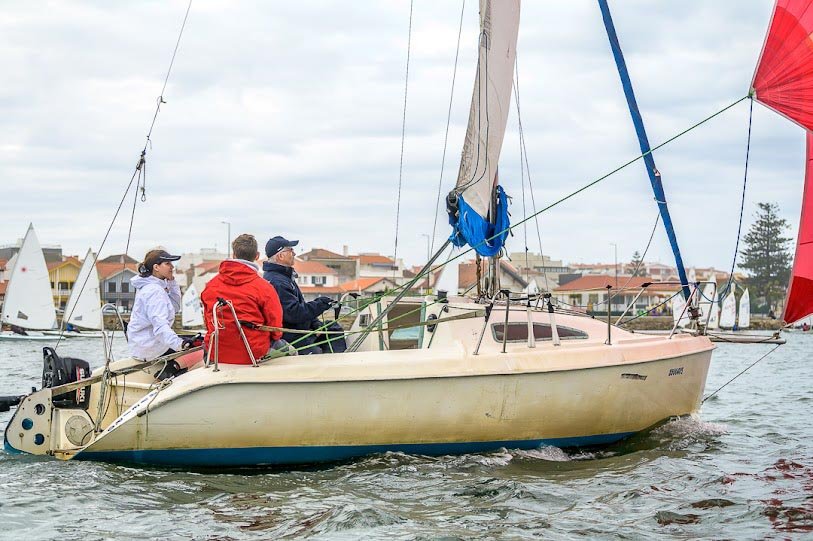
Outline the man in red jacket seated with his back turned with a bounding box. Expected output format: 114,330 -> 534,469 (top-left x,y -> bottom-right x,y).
200,234 -> 295,364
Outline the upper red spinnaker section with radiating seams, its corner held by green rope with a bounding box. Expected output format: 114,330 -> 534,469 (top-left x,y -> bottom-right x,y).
751,0 -> 813,130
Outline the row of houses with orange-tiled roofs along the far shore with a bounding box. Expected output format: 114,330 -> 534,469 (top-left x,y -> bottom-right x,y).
0,237 -> 742,311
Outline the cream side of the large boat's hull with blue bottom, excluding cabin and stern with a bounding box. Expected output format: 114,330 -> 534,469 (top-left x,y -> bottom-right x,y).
76,338 -> 711,465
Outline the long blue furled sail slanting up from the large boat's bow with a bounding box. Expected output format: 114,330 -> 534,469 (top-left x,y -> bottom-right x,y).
598,0 -> 689,300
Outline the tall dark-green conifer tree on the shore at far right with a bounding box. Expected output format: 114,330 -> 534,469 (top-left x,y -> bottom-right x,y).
739,203 -> 791,309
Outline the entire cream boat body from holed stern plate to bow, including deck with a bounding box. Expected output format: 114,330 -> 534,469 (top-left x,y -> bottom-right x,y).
6,307 -> 714,466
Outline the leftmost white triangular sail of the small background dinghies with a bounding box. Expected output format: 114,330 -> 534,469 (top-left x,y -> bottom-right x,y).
0,224 -> 56,329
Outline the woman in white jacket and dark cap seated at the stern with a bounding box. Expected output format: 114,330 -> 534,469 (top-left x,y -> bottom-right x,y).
127,250 -> 190,360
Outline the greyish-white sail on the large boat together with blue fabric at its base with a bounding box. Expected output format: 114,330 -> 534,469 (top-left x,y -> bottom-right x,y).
447,0 -> 520,257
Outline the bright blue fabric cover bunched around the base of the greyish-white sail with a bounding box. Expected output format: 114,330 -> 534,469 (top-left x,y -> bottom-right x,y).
449,185 -> 511,257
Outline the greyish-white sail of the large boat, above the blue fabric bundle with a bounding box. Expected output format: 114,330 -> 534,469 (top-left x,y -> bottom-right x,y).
455,0 -> 520,218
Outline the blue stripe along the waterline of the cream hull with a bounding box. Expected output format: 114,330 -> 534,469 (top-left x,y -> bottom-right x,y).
74,432 -> 633,466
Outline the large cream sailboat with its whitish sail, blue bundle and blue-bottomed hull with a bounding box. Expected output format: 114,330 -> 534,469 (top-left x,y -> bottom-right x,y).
5,0 -> 713,466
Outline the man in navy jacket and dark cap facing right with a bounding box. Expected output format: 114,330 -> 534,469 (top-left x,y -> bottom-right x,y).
263,236 -> 333,355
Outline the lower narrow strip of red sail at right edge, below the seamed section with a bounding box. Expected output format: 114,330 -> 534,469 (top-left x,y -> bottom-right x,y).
782,132 -> 813,323
